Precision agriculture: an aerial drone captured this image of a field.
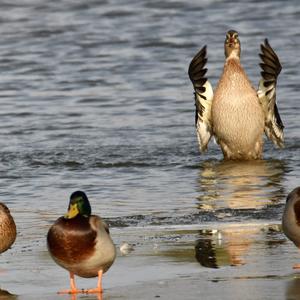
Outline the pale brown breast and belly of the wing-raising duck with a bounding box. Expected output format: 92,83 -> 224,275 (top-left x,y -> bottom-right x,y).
212,57 -> 264,159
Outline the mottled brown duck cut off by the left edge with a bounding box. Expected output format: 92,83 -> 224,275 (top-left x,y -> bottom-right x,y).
0,202 -> 17,253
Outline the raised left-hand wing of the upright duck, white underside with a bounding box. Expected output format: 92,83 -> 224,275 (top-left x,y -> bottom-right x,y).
188,46 -> 213,152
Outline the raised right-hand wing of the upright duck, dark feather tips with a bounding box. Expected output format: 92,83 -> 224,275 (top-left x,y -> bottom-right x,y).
257,39 -> 284,148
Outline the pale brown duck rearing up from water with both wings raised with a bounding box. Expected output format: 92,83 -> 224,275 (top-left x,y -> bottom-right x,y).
188,30 -> 284,160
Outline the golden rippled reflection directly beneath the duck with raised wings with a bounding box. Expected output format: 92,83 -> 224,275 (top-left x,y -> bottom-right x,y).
198,160 -> 285,210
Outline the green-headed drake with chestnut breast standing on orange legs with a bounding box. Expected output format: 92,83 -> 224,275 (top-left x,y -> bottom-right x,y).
47,191 -> 116,294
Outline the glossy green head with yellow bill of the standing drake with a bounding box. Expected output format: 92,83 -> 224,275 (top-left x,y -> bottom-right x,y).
64,191 -> 92,219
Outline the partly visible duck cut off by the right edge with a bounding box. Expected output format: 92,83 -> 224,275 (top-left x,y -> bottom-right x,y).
282,187 -> 300,269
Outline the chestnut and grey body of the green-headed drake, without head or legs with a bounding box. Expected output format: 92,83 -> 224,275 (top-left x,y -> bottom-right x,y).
47,215 -> 116,278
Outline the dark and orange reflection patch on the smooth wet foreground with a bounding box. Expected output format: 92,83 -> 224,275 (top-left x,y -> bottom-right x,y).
195,227 -> 261,268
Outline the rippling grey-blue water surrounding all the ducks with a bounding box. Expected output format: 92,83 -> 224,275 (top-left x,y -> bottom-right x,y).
0,0 -> 300,299
